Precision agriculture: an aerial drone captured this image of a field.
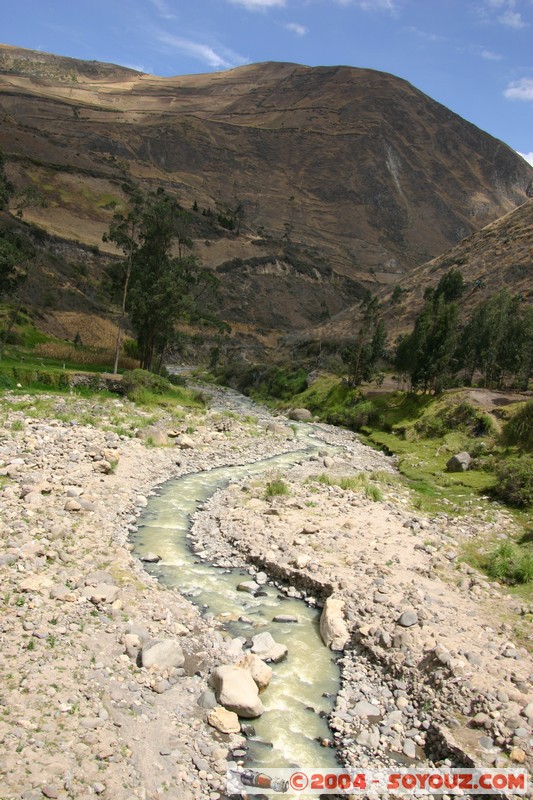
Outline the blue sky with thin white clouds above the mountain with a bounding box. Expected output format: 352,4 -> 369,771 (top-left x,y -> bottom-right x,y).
4,0 -> 533,163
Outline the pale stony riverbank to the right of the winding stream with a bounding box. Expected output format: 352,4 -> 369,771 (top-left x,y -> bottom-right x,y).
192,418 -> 533,780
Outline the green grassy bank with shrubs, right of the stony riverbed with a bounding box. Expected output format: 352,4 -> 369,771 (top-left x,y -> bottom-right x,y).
214,366 -> 533,599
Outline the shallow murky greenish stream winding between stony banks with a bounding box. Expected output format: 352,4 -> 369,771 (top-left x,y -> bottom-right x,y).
132,426 -> 339,784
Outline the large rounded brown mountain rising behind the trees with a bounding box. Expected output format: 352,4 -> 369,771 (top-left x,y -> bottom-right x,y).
0,46 -> 533,350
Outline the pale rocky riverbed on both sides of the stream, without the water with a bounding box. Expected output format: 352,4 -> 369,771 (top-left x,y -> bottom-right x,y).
0,388 -> 533,800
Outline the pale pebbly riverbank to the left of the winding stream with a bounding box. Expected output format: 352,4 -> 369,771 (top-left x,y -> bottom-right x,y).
0,395 -> 308,800
